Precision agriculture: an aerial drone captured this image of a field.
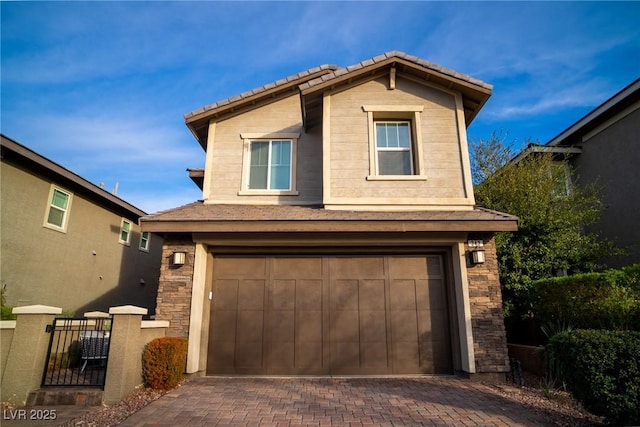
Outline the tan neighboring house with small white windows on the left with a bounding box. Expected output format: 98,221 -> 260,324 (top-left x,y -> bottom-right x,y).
0,135 -> 162,316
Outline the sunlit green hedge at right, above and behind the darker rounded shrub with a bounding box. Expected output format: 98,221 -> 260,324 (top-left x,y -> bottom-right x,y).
530,265 -> 640,330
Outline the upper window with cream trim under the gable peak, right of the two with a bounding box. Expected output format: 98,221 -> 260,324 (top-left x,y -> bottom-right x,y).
362,105 -> 426,180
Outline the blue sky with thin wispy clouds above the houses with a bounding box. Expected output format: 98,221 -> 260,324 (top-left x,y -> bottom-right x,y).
0,1 -> 640,213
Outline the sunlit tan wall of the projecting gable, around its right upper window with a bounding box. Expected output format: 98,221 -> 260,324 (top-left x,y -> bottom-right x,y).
324,77 -> 469,208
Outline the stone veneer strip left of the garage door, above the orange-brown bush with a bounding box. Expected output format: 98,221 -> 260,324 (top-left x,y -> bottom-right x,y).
156,235 -> 196,338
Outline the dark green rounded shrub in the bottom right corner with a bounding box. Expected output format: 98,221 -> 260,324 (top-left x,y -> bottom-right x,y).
547,330 -> 640,425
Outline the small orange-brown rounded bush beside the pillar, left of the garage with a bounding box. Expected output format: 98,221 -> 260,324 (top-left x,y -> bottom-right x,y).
142,337 -> 187,390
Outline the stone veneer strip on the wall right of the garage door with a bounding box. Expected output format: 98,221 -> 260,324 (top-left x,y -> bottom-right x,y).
465,236 -> 509,373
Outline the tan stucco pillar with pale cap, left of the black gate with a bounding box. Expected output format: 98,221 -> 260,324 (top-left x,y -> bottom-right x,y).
2,305 -> 62,405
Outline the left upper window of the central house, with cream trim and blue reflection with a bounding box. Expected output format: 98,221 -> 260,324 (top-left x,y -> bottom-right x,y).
239,133 -> 300,195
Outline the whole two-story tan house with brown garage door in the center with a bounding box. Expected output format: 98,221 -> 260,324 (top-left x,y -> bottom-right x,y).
141,52 -> 517,377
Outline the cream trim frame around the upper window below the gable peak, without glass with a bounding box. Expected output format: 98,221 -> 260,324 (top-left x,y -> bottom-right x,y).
362,105 -> 427,181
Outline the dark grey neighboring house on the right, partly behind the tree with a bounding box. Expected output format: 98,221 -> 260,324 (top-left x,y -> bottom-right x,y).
515,79 -> 640,267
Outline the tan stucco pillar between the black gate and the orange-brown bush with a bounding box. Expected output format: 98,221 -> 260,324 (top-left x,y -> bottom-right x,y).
104,305 -> 147,405
